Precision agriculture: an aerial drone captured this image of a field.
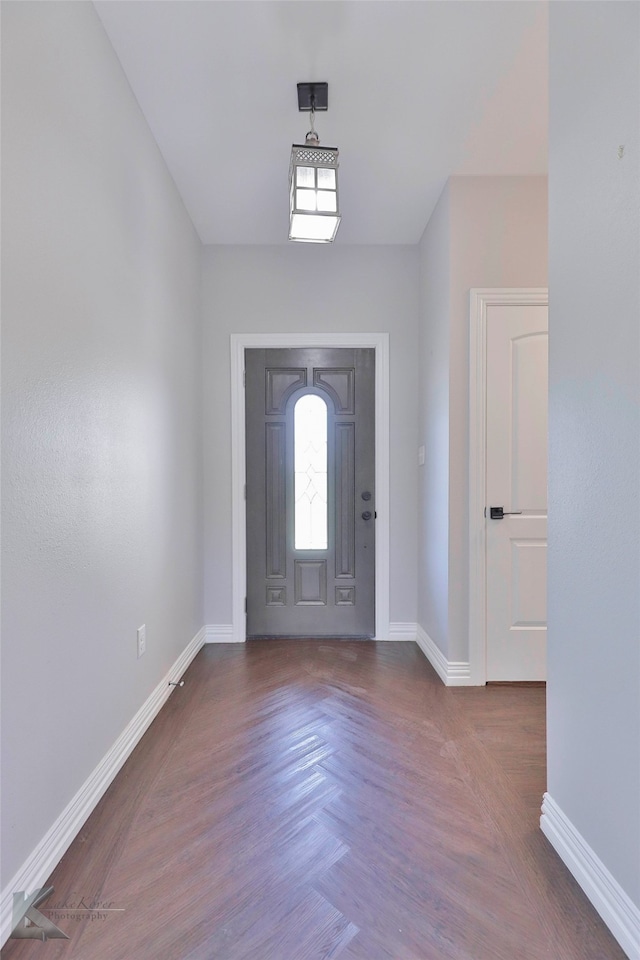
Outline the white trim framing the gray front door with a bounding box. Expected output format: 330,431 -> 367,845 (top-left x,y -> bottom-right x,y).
230,333 -> 390,643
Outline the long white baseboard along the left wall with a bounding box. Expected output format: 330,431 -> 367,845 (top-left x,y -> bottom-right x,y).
0,627 -> 205,945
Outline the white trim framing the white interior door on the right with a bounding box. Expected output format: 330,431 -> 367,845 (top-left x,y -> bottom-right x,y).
469,287 -> 549,686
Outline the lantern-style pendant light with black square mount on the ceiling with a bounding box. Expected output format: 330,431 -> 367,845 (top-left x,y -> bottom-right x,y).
289,83 -> 340,243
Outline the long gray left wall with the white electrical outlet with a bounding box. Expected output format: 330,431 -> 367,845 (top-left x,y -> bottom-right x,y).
2,2 -> 202,886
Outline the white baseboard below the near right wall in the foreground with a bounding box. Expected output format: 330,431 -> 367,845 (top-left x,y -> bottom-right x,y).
540,793 -> 640,960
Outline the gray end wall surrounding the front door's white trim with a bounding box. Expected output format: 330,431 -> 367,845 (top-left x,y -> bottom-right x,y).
203,243 -> 418,624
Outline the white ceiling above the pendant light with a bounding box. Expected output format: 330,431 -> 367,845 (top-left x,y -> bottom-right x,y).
95,0 -> 547,244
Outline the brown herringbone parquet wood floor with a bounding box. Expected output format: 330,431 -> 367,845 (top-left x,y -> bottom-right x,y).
2,640 -> 624,960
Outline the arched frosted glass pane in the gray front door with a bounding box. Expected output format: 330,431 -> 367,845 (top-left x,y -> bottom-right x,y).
293,394 -> 327,550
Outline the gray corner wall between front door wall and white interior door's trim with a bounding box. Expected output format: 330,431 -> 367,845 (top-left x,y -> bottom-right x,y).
419,177 -> 547,661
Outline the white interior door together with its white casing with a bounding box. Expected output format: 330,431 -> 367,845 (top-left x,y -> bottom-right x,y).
469,289 -> 548,684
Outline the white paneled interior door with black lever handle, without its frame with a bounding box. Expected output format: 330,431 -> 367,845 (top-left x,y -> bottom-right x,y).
485,304 -> 548,681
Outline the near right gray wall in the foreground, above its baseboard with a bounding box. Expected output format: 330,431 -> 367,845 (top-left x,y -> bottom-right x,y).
548,2 -> 640,907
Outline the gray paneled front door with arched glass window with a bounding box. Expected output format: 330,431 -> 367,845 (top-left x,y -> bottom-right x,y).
245,348 -> 375,637
